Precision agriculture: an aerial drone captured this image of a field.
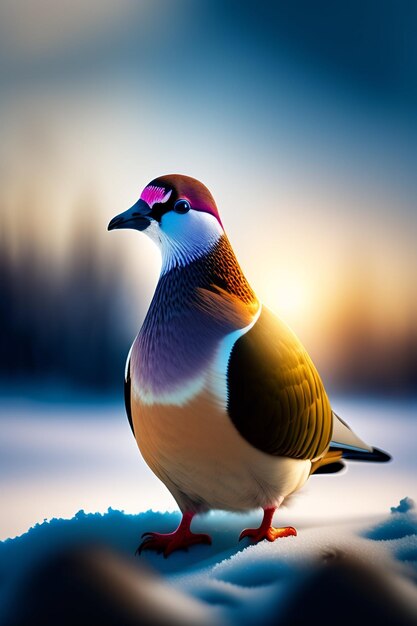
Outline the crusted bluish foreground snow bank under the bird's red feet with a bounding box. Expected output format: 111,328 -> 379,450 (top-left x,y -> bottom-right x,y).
0,498 -> 417,626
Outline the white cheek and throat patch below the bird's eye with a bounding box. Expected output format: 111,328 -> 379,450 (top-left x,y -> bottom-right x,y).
145,209 -> 224,275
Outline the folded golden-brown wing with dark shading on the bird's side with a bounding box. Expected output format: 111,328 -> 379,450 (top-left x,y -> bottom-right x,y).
227,307 -> 332,459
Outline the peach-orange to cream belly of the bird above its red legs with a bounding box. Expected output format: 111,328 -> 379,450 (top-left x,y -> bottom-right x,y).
132,390 -> 311,511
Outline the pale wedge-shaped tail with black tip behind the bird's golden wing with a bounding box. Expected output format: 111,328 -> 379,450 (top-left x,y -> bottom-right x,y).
330,411 -> 391,463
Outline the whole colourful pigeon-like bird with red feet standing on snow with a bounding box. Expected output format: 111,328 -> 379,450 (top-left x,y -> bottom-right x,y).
108,174 -> 390,557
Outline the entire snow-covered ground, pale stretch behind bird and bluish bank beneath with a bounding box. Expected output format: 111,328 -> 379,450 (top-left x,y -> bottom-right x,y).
0,400 -> 417,626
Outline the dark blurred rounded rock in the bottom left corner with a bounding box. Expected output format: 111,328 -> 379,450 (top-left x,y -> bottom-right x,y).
1,548 -> 212,626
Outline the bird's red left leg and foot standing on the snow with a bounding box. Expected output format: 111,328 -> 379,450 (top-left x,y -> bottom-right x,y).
136,511 -> 211,557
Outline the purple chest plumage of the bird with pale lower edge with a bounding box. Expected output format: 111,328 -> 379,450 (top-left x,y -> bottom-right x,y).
131,272 -> 259,406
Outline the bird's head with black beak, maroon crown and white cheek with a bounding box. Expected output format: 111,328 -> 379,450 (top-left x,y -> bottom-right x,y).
108,174 -> 224,269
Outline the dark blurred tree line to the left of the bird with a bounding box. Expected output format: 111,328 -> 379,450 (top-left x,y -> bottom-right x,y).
0,202 -> 137,393
